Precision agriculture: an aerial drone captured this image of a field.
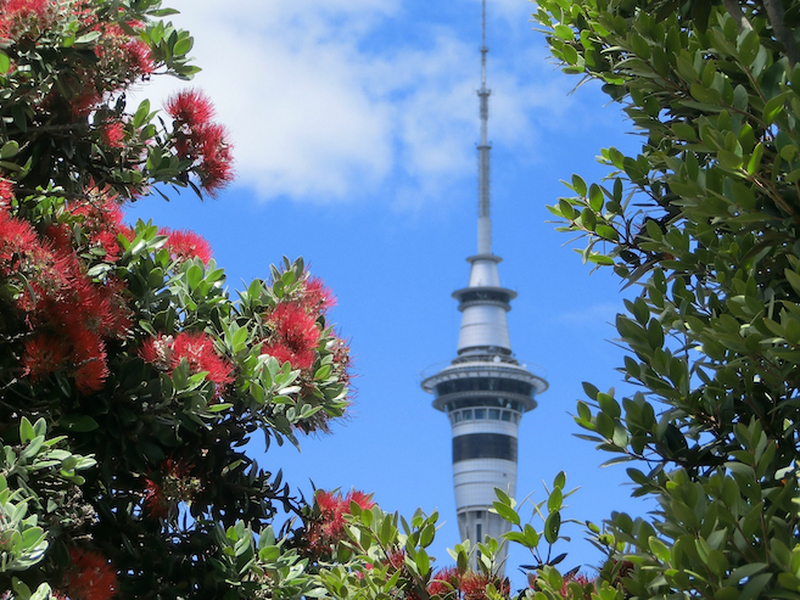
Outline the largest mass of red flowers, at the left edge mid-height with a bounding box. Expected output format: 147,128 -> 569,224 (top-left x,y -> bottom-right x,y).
0,186 -> 130,394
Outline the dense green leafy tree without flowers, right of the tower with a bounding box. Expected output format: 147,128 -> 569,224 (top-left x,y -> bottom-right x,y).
534,0 -> 800,599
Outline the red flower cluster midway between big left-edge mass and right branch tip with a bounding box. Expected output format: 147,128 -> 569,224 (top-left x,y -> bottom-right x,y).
139,331 -> 233,393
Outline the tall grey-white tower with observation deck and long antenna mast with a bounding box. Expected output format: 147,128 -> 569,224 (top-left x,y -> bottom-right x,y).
422,0 -> 547,566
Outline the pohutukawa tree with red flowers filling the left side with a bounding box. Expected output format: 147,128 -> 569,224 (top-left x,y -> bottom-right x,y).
0,0 -> 356,600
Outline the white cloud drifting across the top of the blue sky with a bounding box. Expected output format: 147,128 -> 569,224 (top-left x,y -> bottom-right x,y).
141,0 -> 580,205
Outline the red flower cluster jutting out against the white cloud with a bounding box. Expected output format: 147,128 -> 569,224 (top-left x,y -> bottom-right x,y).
165,90 -> 233,196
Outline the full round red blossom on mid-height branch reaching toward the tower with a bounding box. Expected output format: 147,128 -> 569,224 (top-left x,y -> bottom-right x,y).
261,302 -> 321,369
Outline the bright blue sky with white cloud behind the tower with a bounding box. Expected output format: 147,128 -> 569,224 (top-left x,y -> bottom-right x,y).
129,0 -> 646,585
